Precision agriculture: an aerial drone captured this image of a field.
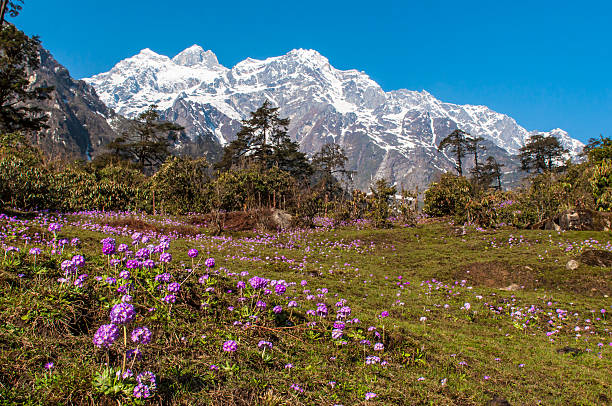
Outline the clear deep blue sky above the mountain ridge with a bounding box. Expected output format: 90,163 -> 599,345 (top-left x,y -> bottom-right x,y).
9,0 -> 612,141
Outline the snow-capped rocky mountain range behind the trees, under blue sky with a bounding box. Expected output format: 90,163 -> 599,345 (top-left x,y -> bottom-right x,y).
84,45 -> 583,188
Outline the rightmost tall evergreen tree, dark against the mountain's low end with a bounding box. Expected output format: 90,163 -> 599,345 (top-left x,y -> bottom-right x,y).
519,134 -> 568,173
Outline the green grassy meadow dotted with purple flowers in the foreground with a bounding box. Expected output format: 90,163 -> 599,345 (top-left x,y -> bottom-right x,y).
0,217 -> 612,405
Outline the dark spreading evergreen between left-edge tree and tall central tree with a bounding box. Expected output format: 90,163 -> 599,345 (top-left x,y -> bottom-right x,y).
106,105 -> 183,173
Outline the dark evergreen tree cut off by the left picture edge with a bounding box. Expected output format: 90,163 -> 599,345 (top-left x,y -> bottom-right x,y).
0,24 -> 53,133
